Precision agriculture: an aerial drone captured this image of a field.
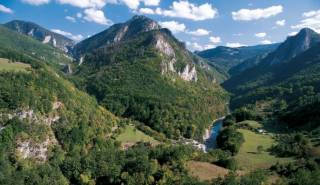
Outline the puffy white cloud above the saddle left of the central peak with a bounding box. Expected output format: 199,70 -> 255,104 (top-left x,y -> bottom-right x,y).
84,8 -> 112,25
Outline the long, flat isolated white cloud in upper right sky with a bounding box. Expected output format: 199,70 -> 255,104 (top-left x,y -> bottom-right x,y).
232,5 -> 283,21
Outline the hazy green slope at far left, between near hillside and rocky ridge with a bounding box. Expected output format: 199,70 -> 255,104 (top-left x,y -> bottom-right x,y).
0,26 -> 72,68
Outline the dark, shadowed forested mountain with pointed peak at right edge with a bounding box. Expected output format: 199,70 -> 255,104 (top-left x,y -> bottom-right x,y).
223,29 -> 320,110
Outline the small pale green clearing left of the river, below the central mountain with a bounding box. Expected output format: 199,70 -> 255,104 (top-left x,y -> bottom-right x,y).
116,125 -> 159,144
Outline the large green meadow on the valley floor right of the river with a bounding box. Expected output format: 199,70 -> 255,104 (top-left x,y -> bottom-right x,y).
235,129 -> 292,171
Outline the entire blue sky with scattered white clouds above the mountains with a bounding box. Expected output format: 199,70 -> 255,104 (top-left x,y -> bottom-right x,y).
0,0 -> 320,50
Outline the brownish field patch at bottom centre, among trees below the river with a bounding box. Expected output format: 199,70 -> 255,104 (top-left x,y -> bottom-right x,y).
187,161 -> 229,181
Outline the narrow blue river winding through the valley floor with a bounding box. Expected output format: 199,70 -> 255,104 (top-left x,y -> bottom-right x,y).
205,117 -> 224,151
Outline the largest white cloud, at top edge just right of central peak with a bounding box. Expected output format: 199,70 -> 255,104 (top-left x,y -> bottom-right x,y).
139,0 -> 218,21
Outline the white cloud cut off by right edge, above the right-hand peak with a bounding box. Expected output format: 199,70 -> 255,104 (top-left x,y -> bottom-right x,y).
291,10 -> 320,33
